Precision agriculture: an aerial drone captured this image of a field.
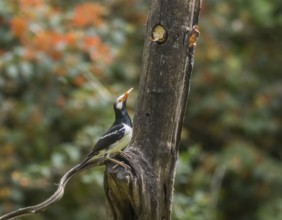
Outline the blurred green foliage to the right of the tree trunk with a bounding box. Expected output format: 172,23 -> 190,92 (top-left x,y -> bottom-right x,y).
174,0 -> 282,220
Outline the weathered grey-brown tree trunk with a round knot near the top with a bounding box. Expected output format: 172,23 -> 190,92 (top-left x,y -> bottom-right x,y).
104,0 -> 201,220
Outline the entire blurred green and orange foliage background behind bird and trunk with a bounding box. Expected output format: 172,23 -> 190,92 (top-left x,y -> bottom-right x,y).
0,0 -> 282,220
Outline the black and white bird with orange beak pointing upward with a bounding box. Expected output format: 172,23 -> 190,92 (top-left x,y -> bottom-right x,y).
76,88 -> 133,167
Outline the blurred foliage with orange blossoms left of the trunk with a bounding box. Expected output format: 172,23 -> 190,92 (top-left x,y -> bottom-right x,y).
0,0 -> 141,219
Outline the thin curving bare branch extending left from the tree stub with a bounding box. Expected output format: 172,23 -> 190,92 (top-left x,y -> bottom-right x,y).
0,158 -> 105,220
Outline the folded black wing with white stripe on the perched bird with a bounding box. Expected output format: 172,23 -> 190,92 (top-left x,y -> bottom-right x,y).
88,124 -> 125,157
